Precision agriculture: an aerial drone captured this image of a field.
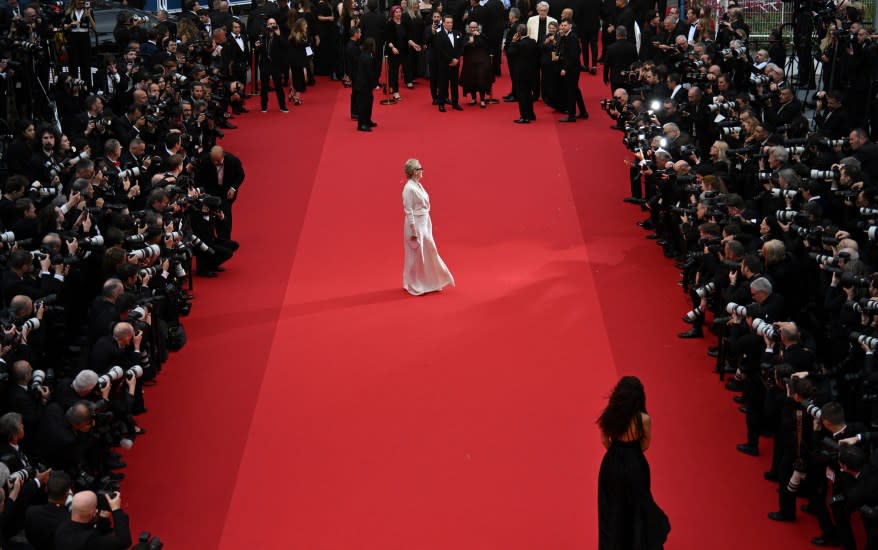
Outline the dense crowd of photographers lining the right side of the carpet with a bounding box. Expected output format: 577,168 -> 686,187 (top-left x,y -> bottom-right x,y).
602,0 -> 878,549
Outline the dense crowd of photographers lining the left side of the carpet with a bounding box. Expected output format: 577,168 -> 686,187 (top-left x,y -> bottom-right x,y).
0,0 -> 256,550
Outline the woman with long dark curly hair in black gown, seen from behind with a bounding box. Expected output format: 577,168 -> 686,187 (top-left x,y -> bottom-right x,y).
598,376 -> 671,550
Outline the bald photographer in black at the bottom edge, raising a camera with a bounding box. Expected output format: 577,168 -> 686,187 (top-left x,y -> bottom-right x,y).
55,491 -> 131,550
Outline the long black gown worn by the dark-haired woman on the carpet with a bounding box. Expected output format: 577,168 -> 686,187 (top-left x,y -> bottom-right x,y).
598,441 -> 671,550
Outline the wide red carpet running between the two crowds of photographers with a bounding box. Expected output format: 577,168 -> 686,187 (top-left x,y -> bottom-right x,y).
123,71 -> 817,550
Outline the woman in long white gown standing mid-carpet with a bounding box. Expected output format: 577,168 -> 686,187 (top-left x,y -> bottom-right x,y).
402,159 -> 454,296
